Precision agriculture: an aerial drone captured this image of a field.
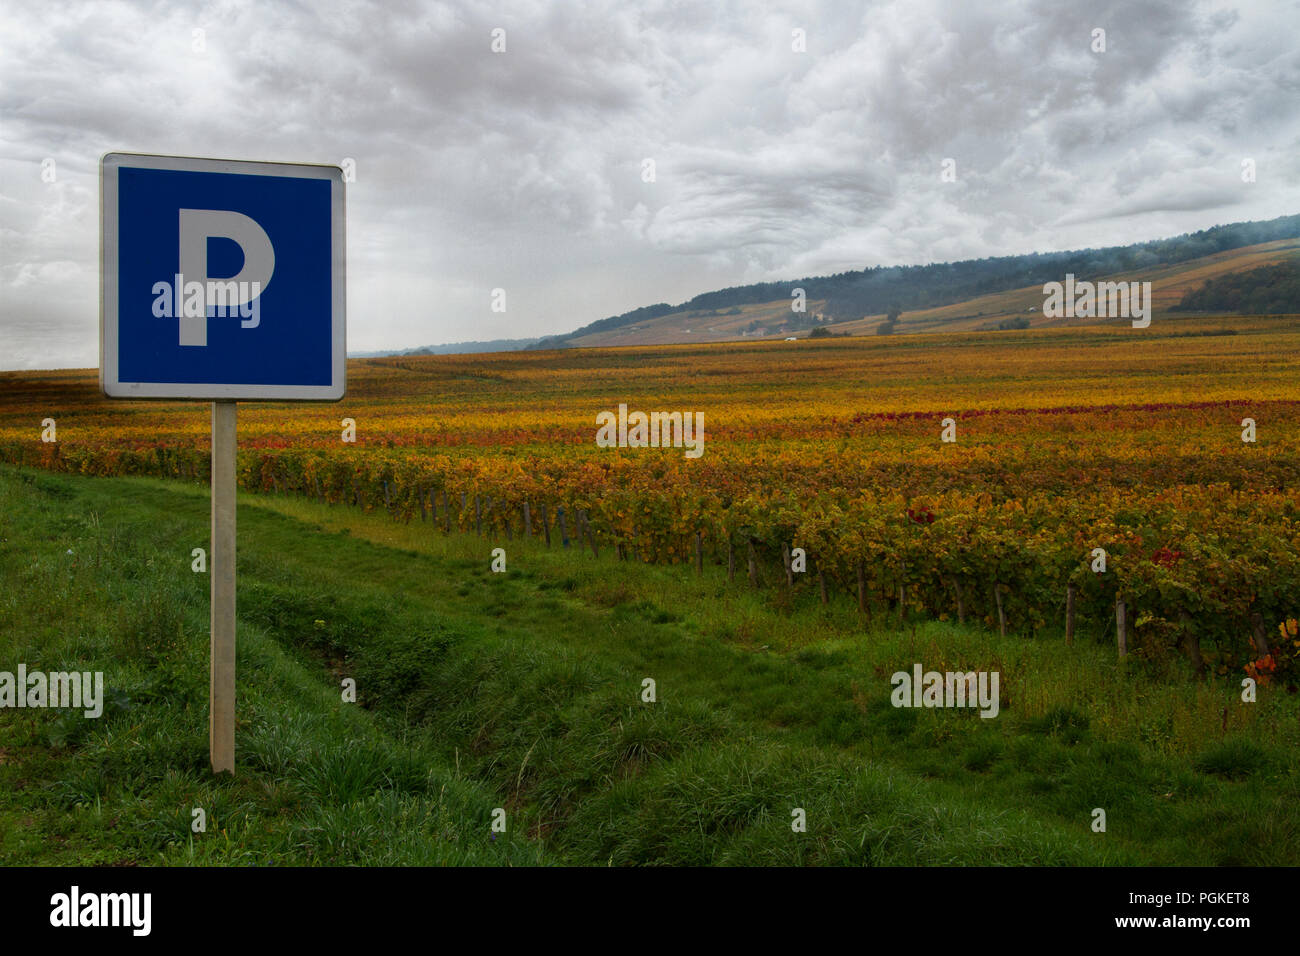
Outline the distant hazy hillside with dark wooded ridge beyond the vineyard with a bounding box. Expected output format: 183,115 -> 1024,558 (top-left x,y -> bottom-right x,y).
530,216 -> 1300,349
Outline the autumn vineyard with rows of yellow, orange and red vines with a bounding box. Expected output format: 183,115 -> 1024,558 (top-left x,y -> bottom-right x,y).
0,317 -> 1300,680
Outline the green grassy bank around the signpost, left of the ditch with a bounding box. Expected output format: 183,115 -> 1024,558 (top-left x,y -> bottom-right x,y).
0,471 -> 546,865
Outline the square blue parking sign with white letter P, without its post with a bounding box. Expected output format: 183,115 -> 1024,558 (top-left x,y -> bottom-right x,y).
100,152 -> 347,401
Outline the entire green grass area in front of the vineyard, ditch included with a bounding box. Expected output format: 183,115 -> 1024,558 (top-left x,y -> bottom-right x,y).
0,468 -> 1300,865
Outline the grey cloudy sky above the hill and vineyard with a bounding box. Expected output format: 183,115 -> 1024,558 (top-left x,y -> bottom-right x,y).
0,0 -> 1300,368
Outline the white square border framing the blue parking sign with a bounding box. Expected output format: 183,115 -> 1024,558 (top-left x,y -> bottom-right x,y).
99,152 -> 347,402
